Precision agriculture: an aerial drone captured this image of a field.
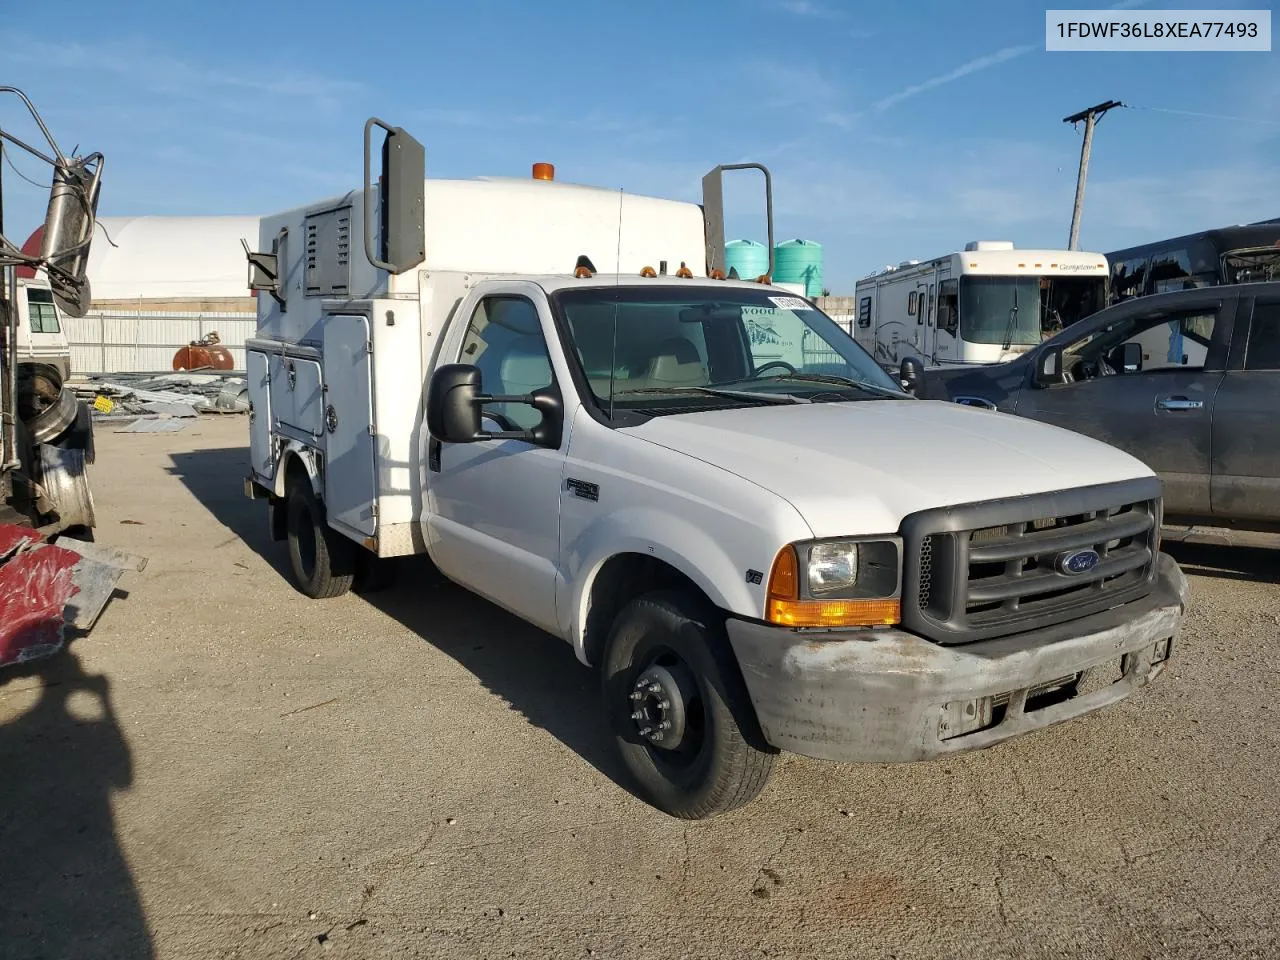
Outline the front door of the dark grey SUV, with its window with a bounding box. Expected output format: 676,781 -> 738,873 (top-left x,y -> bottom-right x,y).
1018,298 -> 1235,516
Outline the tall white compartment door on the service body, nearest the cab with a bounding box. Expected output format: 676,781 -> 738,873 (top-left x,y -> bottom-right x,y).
324,315 -> 378,536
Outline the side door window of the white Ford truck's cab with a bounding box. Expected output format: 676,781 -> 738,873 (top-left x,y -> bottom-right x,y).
458,297 -> 554,430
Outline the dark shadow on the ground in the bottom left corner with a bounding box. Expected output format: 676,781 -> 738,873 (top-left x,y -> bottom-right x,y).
0,652 -> 152,960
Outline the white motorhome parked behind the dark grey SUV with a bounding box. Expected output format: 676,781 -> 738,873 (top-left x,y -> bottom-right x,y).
854,241 -> 1108,369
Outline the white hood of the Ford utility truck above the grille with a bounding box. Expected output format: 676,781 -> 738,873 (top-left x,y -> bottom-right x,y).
626,399 -> 1152,536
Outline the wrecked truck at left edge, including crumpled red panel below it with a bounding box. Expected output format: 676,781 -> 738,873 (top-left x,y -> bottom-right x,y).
0,87 -> 145,667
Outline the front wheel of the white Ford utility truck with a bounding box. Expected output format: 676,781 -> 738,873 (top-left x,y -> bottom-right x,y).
602,591 -> 774,820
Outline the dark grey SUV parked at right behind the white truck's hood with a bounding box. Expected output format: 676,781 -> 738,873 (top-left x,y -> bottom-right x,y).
921,282 -> 1280,545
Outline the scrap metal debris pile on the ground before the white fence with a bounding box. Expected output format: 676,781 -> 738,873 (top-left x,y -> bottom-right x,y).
68,372 -> 248,433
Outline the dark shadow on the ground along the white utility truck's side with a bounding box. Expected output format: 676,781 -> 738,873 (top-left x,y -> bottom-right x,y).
170,447 -> 632,792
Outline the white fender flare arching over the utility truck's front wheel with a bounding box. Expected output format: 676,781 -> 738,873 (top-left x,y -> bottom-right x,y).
557,507 -> 781,663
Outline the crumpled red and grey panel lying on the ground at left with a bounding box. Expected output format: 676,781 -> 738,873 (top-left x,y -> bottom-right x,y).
0,525 -> 147,667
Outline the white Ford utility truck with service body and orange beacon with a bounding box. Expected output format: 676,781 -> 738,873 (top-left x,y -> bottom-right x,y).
246,119 -> 1187,818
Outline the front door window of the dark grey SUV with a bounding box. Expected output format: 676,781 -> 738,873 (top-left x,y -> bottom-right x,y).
1062,312 -> 1217,379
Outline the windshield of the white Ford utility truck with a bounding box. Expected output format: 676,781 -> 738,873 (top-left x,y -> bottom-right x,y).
553,287 -> 906,417
